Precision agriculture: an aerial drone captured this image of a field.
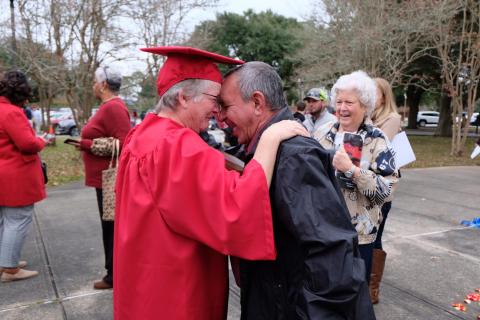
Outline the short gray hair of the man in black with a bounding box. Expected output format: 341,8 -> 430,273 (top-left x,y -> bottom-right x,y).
225,61 -> 287,110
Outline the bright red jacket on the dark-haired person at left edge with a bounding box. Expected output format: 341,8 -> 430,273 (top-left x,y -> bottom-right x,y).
0,96 -> 45,207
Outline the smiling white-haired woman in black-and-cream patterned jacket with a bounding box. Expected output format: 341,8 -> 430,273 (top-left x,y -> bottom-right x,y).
314,71 -> 397,281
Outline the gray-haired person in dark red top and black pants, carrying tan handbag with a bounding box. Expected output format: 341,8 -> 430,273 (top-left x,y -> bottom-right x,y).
80,67 -> 131,289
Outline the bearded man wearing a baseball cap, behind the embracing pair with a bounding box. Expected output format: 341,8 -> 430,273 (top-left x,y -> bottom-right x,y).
303,88 -> 336,134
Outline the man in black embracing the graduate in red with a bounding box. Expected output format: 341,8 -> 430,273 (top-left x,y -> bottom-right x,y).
220,62 -> 375,320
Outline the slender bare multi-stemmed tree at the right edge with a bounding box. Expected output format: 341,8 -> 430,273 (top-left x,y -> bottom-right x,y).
423,0 -> 480,156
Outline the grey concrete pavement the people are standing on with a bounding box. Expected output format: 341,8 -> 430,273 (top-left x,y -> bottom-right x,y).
0,167 -> 480,320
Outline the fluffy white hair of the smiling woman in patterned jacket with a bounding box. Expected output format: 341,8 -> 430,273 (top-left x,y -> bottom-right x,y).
332,70 -> 377,117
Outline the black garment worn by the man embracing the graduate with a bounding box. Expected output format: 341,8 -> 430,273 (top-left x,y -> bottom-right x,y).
236,108 -> 375,320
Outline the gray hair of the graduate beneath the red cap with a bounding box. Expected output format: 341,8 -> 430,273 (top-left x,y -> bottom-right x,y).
155,79 -> 212,113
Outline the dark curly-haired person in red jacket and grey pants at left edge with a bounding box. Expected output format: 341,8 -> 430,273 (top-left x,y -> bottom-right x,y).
0,71 -> 45,282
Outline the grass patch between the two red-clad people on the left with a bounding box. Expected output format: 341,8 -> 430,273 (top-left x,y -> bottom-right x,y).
40,136 -> 84,186
